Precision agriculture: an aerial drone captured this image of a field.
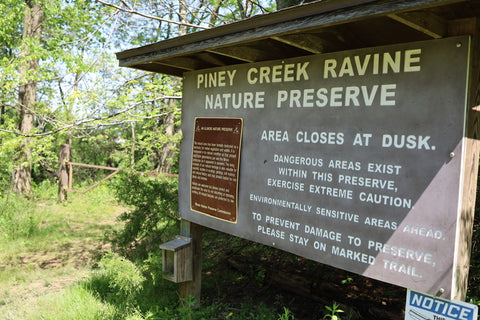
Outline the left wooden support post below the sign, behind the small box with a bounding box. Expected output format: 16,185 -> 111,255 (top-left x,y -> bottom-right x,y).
179,220 -> 203,305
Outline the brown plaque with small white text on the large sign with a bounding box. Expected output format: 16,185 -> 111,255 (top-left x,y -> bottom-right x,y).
190,118 -> 243,222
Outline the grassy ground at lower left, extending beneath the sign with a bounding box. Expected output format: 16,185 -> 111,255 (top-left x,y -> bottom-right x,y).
0,185 -> 293,320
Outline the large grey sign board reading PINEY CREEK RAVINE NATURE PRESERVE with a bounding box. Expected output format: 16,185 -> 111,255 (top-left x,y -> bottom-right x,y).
179,37 -> 469,295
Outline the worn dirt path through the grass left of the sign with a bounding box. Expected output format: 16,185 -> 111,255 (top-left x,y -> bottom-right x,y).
0,198 -> 125,320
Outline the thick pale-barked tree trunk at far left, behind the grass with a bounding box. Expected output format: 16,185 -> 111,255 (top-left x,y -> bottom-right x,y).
12,0 -> 43,196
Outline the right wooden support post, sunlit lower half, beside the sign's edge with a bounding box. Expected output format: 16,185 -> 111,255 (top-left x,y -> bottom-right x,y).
448,18 -> 480,301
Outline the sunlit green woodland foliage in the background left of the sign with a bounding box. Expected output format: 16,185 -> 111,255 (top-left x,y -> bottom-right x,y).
0,0 -> 266,198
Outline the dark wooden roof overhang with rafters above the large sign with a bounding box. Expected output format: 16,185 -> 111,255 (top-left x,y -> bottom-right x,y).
117,0 -> 480,76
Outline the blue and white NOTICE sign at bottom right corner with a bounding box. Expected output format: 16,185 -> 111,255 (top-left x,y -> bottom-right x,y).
405,290 -> 478,320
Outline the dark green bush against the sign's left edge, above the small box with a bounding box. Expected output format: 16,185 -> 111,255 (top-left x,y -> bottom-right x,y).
110,173 -> 178,259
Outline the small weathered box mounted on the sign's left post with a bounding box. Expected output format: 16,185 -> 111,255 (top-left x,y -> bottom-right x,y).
160,236 -> 193,283
